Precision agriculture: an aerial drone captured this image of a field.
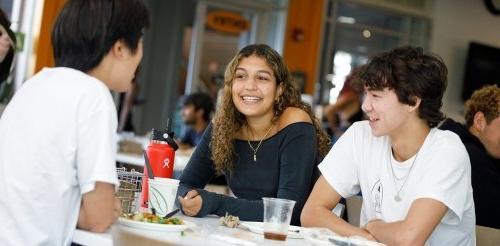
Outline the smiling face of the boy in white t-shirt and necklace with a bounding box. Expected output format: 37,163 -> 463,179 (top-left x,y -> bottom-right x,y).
361,88 -> 410,137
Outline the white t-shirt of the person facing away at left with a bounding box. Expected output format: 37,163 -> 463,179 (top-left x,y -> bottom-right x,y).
0,67 -> 118,245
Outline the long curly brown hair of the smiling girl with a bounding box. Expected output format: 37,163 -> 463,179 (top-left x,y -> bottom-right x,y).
210,44 -> 330,172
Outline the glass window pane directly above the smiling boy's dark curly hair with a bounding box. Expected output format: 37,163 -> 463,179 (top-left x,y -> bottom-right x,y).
317,0 -> 431,104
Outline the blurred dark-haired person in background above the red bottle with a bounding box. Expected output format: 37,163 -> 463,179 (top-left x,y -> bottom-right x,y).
177,92 -> 214,150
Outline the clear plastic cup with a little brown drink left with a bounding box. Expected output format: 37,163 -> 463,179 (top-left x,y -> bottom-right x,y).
262,197 -> 295,241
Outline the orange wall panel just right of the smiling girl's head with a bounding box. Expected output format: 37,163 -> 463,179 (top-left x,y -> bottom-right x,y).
283,0 -> 324,94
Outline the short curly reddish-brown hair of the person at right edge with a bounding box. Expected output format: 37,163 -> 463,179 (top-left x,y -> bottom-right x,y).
465,85 -> 500,127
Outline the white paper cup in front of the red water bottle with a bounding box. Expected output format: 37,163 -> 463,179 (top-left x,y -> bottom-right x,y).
149,178 -> 179,217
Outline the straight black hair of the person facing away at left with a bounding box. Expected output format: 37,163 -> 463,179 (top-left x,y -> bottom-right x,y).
52,0 -> 149,72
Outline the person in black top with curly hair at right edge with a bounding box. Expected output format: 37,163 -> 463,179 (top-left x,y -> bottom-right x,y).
439,85 -> 500,229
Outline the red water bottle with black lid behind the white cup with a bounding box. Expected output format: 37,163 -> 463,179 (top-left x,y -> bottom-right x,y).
140,126 -> 179,208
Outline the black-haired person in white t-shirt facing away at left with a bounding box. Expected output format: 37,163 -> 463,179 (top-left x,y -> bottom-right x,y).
0,0 -> 149,245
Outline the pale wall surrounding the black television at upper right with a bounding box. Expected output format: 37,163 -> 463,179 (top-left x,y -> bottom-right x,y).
431,0 -> 500,120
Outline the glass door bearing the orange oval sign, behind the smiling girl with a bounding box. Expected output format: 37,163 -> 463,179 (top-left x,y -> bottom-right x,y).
184,0 -> 287,100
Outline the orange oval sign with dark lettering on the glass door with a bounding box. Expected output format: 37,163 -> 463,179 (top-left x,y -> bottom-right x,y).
207,11 -> 250,34
